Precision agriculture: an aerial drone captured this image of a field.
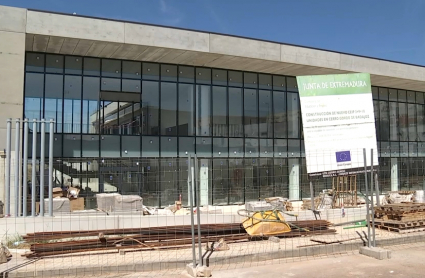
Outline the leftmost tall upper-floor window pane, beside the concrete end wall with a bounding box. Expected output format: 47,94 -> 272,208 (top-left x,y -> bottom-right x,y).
25,73 -> 44,120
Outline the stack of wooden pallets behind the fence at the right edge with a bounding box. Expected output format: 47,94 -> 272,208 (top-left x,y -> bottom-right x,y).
375,203 -> 425,234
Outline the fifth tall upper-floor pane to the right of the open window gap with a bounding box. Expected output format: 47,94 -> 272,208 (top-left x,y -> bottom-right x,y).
212,86 -> 228,136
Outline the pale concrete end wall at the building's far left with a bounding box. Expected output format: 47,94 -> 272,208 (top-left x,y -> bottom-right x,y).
0,6 -> 27,208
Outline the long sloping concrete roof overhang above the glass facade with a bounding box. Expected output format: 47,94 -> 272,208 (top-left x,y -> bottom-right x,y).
21,10 -> 425,92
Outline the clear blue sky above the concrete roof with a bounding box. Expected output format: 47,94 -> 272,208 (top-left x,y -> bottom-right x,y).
0,0 -> 425,66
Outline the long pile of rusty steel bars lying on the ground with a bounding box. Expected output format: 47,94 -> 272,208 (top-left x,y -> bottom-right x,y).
22,220 -> 335,258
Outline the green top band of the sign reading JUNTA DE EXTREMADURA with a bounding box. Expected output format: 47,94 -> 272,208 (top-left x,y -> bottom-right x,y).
297,73 -> 372,97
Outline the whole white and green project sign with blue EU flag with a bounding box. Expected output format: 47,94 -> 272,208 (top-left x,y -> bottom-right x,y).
297,73 -> 378,177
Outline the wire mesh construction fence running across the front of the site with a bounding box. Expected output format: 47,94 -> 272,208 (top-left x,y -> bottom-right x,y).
0,150 -> 425,277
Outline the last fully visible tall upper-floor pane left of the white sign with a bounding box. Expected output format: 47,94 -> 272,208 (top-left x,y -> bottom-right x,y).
273,91 -> 288,138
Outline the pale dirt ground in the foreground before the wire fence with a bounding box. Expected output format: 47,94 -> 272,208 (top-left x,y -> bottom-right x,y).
86,243 -> 425,278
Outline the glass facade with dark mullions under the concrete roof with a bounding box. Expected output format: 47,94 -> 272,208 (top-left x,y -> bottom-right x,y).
24,52 -> 425,206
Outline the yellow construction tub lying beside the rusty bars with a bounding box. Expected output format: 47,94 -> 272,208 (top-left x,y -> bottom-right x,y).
242,210 -> 291,236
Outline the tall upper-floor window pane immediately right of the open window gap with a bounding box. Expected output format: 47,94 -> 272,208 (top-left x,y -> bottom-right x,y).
141,81 -> 159,135
